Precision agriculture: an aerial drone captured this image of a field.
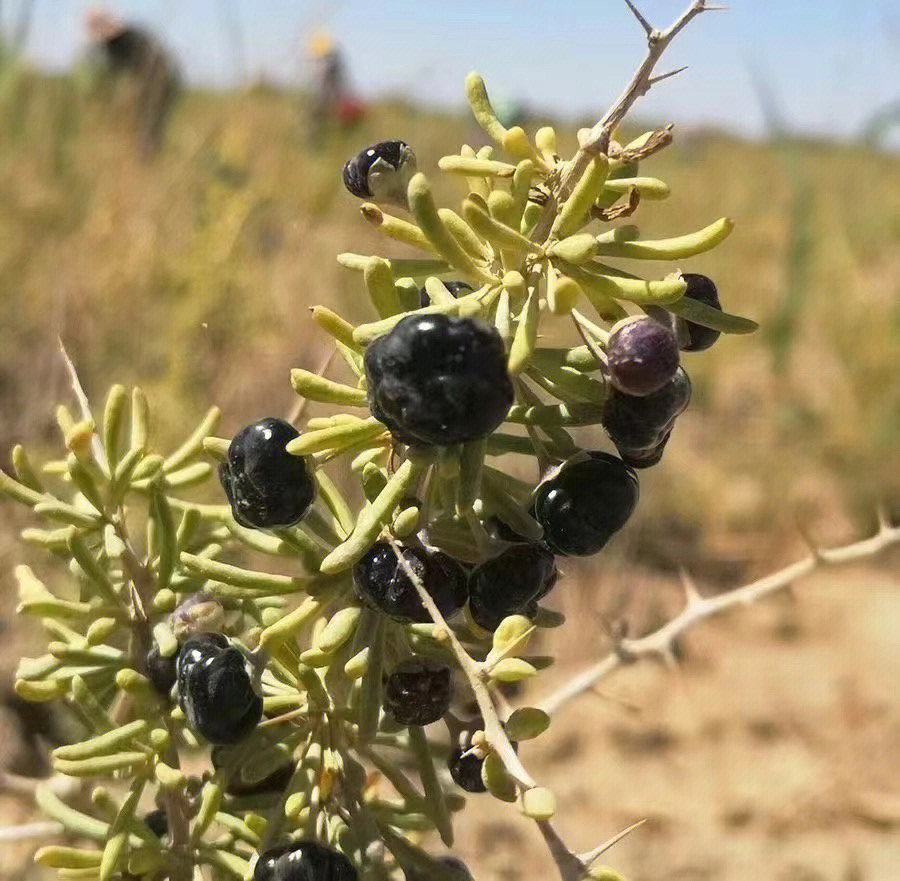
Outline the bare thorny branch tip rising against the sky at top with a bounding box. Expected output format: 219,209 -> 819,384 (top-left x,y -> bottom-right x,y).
532,0 -> 723,242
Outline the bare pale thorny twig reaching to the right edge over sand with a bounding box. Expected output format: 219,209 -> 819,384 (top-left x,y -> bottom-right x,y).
537,518 -> 900,716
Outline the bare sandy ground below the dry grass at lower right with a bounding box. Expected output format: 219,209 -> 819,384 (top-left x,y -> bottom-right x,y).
0,552 -> 900,881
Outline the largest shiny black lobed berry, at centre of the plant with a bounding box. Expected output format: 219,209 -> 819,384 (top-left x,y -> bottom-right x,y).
364,315 -> 513,445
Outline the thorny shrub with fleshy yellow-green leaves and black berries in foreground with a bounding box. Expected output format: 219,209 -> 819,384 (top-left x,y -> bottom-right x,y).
0,0 -> 900,881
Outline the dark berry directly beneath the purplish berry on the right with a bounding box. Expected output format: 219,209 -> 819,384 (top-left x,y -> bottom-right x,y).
602,367 -> 691,464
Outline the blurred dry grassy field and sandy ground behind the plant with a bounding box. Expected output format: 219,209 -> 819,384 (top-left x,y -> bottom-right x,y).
0,3 -> 900,881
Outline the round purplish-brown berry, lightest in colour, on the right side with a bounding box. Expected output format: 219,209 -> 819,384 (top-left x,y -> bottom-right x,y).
606,317 -> 678,395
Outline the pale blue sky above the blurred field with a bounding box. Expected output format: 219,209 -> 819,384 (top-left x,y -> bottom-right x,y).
8,0 -> 900,136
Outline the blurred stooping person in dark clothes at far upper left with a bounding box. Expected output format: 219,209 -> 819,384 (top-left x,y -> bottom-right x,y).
85,8 -> 178,156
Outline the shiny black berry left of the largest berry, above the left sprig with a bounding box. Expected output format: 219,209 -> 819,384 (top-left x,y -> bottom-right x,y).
219,417 -> 316,529
